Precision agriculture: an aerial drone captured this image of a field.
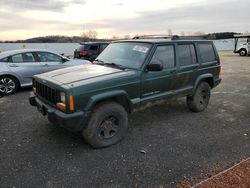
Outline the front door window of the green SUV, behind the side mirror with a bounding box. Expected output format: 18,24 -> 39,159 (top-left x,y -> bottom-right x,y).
150,45 -> 175,69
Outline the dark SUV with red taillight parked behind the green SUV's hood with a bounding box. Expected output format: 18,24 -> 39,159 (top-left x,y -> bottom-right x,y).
74,42 -> 109,61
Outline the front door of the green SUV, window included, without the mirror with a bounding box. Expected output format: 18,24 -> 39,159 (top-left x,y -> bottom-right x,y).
141,45 -> 176,101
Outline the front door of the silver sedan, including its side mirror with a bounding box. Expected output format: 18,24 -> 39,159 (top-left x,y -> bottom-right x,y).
37,52 -> 67,72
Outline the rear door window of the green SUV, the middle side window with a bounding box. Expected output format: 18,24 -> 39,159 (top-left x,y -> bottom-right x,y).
178,44 -> 197,66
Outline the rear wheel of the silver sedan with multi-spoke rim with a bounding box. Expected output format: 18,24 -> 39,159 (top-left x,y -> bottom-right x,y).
0,75 -> 19,95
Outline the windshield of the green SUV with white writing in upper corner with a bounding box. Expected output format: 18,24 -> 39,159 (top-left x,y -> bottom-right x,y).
96,42 -> 151,69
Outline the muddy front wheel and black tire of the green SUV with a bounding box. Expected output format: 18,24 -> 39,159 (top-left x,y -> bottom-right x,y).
82,101 -> 128,148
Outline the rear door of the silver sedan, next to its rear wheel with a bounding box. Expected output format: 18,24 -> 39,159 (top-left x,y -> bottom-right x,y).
7,52 -> 42,85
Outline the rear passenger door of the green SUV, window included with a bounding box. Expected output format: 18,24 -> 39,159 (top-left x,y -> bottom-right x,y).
174,42 -> 199,94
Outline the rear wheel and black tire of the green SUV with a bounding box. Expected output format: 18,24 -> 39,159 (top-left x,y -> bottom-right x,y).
187,82 -> 211,112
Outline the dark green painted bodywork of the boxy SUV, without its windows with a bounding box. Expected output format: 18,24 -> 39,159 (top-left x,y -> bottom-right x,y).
31,40 -> 220,129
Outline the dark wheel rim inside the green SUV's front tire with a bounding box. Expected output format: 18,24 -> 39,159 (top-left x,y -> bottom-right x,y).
99,115 -> 119,139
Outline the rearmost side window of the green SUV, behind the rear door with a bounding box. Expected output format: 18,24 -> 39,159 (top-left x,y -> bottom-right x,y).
198,43 -> 216,63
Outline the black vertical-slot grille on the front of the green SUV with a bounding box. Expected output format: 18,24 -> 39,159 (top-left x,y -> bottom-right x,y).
34,80 -> 59,104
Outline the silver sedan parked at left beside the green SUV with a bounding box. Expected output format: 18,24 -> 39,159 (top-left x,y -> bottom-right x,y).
0,49 -> 88,94
